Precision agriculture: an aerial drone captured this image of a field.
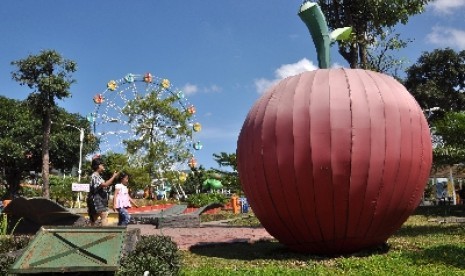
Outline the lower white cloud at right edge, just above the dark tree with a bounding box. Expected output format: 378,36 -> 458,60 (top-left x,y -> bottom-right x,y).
426,26 -> 465,50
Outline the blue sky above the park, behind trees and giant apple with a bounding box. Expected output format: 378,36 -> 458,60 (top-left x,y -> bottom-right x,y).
0,0 -> 465,168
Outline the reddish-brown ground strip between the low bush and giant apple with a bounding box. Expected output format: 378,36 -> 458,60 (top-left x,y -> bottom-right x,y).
128,222 -> 274,250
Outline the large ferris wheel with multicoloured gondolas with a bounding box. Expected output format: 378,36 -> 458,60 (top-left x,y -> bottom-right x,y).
87,73 -> 203,167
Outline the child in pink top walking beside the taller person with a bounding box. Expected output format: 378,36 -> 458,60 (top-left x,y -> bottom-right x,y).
113,172 -> 139,226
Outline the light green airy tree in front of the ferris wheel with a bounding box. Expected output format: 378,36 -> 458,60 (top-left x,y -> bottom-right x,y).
122,83 -> 192,177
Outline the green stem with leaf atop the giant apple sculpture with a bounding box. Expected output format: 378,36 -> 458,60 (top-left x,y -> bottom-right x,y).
299,1 -> 352,69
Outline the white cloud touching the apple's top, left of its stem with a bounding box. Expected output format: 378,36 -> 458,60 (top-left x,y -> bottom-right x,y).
255,58 -> 318,94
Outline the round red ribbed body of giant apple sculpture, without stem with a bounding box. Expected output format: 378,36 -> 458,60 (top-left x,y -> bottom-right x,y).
237,2 -> 432,254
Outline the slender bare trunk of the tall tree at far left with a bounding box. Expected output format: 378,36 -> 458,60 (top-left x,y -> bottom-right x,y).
42,108 -> 52,198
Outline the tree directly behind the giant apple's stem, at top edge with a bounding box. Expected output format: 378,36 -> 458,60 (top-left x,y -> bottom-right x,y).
317,0 -> 431,69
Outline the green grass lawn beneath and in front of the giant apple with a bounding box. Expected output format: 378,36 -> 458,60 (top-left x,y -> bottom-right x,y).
181,206 -> 465,275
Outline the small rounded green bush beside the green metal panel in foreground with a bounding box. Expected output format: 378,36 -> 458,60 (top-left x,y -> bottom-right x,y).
117,236 -> 181,276
